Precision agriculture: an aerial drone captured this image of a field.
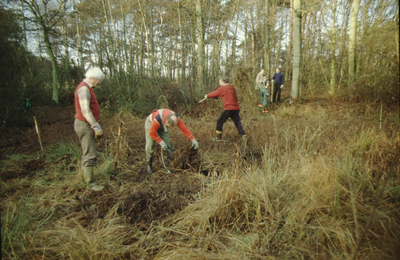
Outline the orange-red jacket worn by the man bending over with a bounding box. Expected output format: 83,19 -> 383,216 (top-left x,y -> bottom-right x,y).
149,109 -> 194,143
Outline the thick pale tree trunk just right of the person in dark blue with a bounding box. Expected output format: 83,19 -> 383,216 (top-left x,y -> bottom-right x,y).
290,0 -> 301,99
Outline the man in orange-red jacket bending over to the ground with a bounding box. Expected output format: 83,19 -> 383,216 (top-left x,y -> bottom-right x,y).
144,109 -> 199,173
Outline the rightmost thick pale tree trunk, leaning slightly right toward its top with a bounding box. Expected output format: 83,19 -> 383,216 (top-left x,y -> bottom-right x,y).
348,0 -> 361,94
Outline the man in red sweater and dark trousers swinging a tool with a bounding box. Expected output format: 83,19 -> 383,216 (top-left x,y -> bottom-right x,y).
205,76 -> 246,144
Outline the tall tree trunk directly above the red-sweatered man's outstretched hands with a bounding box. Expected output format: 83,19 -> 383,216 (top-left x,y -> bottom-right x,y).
196,0 -> 205,93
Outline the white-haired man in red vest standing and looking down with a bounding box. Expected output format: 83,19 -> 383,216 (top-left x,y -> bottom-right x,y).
74,67 -> 105,191
